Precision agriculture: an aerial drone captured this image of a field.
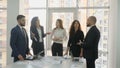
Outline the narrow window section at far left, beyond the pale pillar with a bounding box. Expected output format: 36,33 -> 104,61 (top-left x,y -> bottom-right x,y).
0,0 -> 7,68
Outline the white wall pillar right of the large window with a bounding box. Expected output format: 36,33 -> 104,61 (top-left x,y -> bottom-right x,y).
108,0 -> 118,68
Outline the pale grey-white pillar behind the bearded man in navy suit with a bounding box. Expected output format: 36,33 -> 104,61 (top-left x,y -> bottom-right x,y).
7,0 -> 24,64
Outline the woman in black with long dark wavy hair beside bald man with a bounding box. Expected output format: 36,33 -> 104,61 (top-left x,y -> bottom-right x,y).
65,20 -> 84,57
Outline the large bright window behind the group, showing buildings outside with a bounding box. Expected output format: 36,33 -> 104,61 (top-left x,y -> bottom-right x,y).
25,0 -> 110,68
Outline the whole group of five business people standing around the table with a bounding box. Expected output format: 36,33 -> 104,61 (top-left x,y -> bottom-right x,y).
10,15 -> 100,68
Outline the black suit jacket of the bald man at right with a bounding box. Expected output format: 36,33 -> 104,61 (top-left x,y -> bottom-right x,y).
82,26 -> 100,59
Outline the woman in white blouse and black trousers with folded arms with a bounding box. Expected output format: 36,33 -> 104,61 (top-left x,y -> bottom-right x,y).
51,19 -> 67,56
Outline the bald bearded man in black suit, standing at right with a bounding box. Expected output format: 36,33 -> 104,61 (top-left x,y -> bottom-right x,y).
81,16 -> 100,68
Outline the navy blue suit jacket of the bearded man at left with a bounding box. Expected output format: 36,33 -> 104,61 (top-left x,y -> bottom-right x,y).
10,25 -> 29,58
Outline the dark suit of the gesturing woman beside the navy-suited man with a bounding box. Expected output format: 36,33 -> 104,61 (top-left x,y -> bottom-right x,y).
30,26 -> 46,56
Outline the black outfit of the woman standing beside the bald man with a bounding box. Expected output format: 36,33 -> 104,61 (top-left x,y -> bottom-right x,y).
67,30 -> 84,57
